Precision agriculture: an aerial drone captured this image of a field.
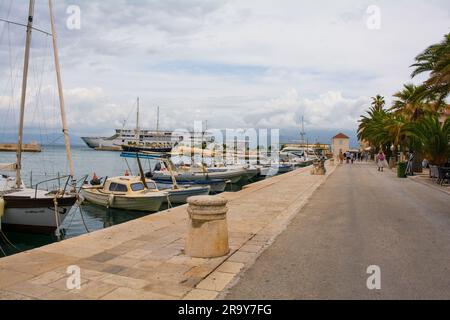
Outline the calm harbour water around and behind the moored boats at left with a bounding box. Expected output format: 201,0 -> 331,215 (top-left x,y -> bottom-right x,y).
0,146 -> 246,257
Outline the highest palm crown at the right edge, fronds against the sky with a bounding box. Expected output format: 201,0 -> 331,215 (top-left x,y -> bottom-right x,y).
411,33 -> 450,107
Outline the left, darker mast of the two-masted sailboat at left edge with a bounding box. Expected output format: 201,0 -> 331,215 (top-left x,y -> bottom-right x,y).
16,0 -> 34,189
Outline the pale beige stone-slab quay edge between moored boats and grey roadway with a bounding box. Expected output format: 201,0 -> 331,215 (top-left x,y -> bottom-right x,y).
0,167 -> 334,300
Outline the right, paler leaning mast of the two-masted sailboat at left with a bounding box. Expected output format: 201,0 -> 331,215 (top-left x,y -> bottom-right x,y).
48,0 -> 75,178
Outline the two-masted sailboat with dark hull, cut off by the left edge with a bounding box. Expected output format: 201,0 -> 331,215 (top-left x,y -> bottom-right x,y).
0,0 -> 77,234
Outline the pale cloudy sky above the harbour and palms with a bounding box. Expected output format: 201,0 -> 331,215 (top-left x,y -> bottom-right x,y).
0,0 -> 450,142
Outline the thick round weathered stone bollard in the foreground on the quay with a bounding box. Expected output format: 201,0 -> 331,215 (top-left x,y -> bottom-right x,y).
185,196 -> 230,258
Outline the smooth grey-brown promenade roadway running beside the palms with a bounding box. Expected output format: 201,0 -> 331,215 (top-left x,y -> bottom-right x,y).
227,164 -> 450,299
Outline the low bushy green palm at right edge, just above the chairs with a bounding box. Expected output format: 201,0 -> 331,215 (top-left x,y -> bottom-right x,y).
404,114 -> 450,166
